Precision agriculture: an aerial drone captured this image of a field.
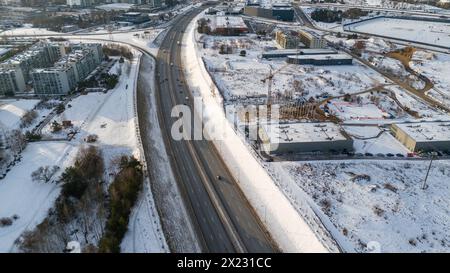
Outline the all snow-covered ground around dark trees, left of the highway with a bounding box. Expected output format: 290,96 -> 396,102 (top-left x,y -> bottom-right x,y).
0,49 -> 167,252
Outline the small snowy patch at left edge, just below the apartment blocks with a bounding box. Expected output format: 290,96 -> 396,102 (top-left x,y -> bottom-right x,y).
0,99 -> 39,130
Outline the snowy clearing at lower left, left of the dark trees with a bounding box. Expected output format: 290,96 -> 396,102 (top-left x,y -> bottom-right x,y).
0,142 -> 77,252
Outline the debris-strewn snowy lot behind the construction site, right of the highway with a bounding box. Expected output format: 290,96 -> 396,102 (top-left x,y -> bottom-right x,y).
202,36 -> 384,101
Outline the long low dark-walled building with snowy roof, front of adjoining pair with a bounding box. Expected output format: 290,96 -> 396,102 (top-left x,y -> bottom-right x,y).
287,54 -> 353,65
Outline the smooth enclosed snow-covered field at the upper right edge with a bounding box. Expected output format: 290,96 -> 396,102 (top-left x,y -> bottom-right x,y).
344,18 -> 450,48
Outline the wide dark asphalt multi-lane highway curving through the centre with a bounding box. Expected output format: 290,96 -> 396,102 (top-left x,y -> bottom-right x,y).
156,8 -> 278,252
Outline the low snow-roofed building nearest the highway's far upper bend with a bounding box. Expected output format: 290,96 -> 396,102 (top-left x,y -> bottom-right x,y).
209,15 -> 248,36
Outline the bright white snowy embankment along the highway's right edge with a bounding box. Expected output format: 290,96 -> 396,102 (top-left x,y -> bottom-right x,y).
182,14 -> 328,252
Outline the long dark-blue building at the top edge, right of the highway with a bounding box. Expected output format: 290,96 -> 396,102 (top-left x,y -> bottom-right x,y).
244,0 -> 294,22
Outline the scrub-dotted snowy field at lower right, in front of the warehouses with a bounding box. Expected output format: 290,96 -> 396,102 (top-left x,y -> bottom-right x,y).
271,161 -> 450,252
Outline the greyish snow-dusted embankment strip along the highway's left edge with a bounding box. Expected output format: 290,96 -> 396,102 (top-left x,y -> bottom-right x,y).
134,56 -> 201,253
